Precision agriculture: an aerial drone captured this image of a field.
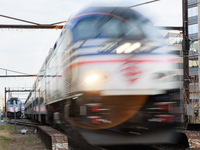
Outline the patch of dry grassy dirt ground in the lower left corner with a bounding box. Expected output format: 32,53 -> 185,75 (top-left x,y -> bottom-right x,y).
0,126 -> 47,150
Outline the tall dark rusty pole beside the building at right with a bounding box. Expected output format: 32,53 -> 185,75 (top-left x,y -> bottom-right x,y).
182,0 -> 190,126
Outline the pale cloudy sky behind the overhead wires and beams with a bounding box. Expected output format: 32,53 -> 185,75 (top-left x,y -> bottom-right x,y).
0,0 -> 182,101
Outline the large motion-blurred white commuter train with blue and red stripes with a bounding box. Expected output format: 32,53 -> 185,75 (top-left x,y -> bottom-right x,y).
25,7 -> 181,145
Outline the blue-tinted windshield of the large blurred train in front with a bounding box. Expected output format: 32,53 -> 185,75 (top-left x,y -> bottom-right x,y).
74,16 -> 160,41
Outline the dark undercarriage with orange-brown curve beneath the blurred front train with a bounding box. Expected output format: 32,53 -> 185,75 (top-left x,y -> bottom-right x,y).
43,90 -> 183,145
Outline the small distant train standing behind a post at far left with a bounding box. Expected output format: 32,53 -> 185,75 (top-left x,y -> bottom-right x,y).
6,97 -> 21,118
